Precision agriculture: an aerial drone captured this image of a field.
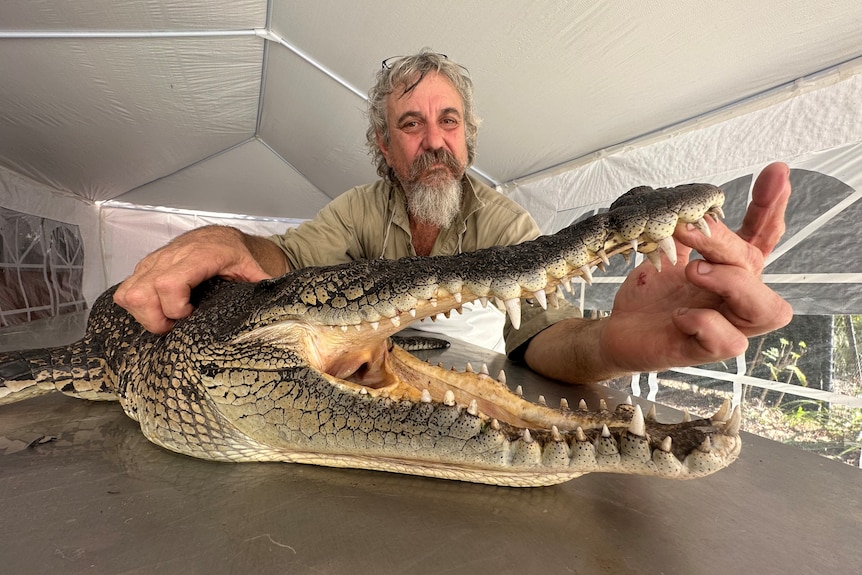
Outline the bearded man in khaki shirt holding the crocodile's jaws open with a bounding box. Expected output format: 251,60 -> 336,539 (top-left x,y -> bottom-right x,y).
114,51 -> 792,383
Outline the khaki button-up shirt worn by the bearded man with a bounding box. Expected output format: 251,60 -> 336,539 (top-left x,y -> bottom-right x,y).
269,176 -> 580,356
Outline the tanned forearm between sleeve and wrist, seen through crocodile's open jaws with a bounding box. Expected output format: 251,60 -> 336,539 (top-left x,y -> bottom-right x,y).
524,318 -> 627,383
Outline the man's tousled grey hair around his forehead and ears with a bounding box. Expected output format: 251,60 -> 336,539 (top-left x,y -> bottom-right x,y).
365,48 -> 481,182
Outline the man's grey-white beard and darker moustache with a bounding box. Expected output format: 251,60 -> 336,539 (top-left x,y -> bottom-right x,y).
401,149 -> 464,228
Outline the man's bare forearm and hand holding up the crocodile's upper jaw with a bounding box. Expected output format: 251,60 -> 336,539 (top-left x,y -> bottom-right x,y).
524,163 -> 793,383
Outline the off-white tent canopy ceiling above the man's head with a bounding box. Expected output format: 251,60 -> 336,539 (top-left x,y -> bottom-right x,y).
0,0 -> 862,217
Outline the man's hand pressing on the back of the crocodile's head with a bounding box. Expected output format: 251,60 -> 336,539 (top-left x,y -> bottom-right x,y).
114,226 -> 286,333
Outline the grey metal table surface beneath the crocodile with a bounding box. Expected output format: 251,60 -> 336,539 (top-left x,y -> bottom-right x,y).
0,322 -> 862,575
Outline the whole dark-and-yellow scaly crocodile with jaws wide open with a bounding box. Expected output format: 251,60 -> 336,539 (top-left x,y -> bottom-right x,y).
0,184 -> 741,486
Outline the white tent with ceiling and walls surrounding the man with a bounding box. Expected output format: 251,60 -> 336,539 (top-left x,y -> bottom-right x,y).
0,0 -> 862,313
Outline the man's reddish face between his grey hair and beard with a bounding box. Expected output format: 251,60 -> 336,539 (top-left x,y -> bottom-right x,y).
377,73 -> 467,191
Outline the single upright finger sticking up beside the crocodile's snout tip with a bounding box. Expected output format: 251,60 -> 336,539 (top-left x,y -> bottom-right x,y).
737,162 -> 790,256
